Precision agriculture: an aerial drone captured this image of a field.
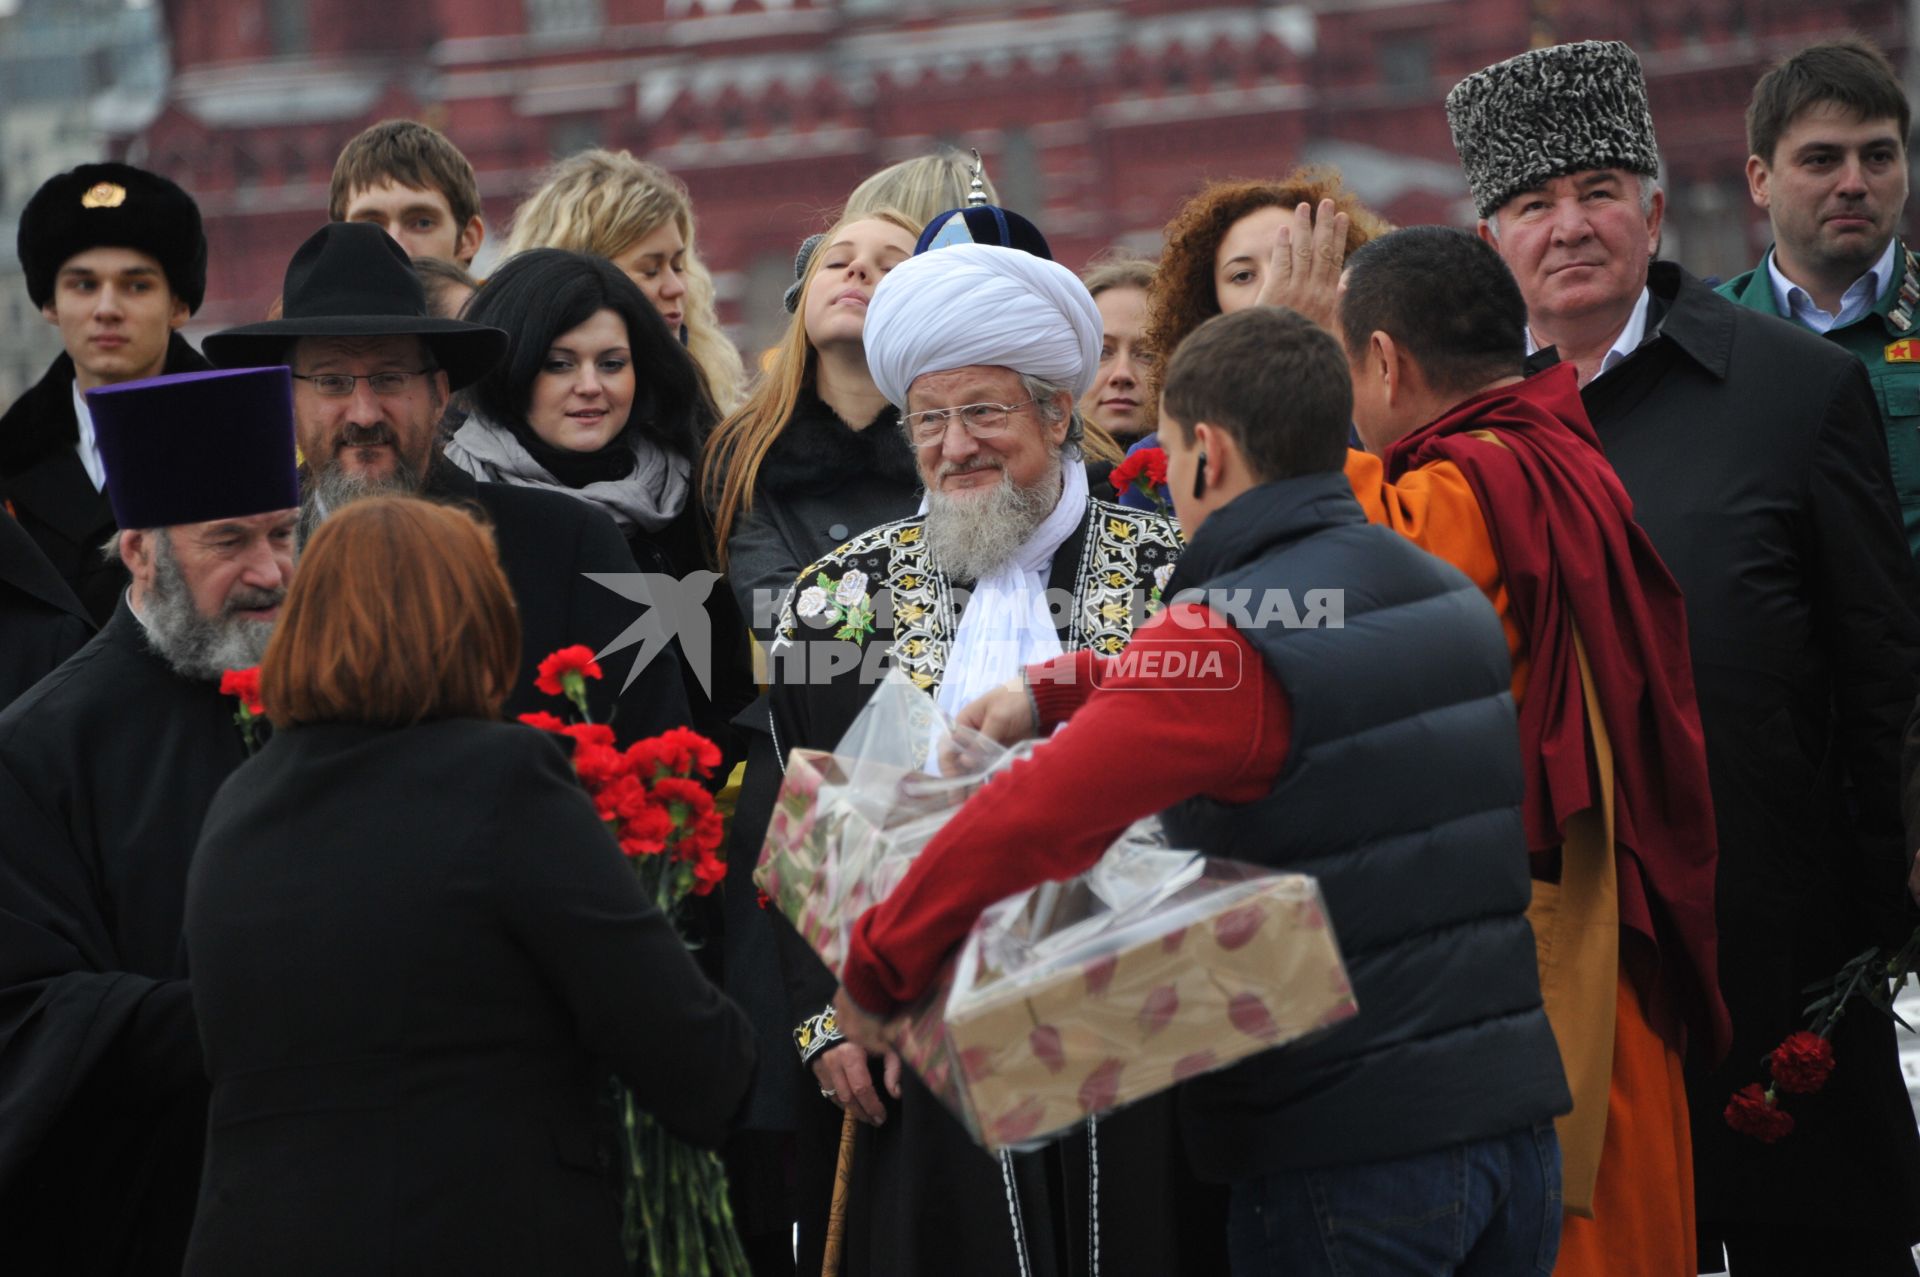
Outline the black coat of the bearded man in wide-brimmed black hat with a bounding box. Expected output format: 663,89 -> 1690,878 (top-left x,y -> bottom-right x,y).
422,461 -> 691,741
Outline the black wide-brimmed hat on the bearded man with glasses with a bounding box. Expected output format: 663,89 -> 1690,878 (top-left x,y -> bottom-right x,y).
202,221 -> 507,390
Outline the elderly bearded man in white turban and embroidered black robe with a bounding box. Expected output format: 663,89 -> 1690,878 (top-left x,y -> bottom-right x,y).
743,244 -> 1198,1277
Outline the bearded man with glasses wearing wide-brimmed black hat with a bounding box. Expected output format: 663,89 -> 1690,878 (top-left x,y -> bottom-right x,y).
205,223 -> 687,739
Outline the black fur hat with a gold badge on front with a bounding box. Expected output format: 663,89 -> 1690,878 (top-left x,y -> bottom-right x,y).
17,163 -> 207,311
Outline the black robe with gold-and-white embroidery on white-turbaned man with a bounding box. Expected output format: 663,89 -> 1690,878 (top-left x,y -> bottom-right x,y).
730,501 -> 1227,1277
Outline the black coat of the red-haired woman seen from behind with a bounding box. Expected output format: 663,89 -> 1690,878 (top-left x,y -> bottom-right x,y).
186,718 -> 753,1277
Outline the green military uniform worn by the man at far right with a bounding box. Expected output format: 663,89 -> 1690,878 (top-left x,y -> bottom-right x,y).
1718,242 -> 1920,559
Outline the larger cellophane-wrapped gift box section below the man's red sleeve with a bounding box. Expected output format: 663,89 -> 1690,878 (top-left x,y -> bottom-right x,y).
899,845 -> 1357,1148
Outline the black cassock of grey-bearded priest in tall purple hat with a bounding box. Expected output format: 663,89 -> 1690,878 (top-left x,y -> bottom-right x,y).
0,599 -> 246,1277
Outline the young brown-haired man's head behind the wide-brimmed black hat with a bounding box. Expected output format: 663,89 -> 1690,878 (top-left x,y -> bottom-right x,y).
326,119 -> 486,267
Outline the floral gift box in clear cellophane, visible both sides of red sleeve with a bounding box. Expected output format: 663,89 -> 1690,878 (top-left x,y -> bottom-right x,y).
755,676 -> 1357,1150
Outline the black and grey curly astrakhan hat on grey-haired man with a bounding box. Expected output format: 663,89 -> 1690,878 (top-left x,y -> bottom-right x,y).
1446,40 -> 1661,217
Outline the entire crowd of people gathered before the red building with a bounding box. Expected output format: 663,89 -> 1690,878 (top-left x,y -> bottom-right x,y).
0,27 -> 1920,1277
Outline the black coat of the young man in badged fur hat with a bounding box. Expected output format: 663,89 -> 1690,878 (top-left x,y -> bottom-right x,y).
0,332 -> 213,626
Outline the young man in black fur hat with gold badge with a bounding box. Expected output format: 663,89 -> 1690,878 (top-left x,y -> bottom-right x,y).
0,163 -> 207,624
